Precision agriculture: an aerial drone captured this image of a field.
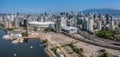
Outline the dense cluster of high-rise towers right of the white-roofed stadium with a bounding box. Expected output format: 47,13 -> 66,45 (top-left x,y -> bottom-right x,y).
56,12 -> 115,32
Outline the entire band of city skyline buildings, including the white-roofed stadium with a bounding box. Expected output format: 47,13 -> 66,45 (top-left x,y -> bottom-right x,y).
0,11 -> 119,33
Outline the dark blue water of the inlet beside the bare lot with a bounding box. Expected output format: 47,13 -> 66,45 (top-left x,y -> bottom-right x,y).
0,29 -> 48,57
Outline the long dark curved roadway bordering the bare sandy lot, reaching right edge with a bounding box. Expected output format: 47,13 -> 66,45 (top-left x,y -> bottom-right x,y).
62,32 -> 120,50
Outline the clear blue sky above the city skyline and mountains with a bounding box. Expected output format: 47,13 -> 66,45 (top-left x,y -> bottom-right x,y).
0,0 -> 120,13
